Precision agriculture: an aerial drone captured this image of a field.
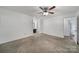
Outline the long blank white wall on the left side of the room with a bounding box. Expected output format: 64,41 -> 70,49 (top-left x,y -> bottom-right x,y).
0,8 -> 33,43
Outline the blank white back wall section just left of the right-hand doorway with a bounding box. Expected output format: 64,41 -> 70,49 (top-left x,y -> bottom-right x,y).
43,16 -> 64,38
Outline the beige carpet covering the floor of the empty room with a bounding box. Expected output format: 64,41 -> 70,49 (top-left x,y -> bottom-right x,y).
0,33 -> 79,53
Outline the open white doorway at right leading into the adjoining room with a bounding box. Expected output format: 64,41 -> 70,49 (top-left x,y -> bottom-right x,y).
64,16 -> 77,43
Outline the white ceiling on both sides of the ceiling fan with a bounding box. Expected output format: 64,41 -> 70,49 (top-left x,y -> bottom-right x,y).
0,6 -> 79,16
